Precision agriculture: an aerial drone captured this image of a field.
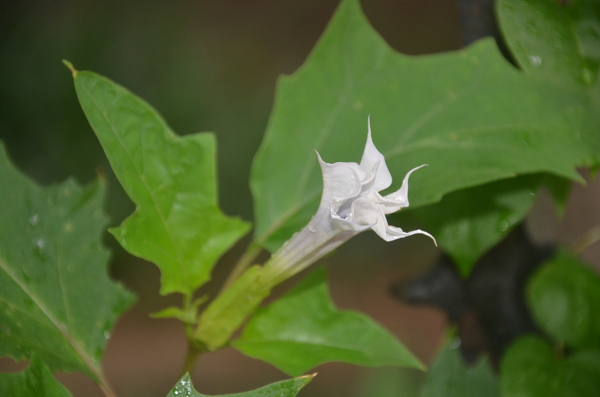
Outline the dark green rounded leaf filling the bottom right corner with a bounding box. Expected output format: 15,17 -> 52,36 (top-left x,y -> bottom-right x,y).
500,336 -> 600,397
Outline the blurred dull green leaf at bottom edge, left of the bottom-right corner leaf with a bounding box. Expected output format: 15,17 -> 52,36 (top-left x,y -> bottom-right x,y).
420,338 -> 500,397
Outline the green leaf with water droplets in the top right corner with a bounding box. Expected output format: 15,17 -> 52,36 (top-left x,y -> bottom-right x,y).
497,0 -> 600,87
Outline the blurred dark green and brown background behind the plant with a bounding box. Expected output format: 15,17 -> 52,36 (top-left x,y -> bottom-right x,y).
0,0 -> 600,397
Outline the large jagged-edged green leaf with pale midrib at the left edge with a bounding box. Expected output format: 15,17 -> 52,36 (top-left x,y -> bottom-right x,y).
0,145 -> 133,380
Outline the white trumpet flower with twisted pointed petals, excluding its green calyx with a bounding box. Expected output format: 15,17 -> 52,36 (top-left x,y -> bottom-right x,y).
265,120 -> 437,283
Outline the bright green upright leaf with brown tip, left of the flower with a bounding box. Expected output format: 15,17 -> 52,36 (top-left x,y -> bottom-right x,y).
73,65 -> 250,295
